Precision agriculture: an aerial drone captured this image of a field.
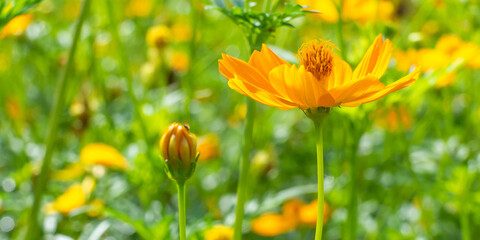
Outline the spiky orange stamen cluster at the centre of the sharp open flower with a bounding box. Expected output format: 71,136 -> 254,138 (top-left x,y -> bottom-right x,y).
296,40 -> 335,80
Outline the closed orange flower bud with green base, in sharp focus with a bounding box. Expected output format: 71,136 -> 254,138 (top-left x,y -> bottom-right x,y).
160,123 -> 198,181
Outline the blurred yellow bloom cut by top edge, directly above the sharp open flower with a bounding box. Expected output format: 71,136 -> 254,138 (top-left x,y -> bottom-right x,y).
297,0 -> 395,23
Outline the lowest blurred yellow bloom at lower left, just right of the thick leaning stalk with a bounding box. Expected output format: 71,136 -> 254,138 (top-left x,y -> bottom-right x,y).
52,183 -> 86,214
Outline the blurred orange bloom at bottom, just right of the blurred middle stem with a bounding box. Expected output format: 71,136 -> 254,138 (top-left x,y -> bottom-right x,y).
251,213 -> 297,237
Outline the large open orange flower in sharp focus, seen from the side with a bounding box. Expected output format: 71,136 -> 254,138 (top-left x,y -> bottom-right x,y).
219,35 -> 420,110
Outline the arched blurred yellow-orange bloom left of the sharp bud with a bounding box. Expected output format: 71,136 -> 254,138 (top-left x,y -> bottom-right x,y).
80,143 -> 128,169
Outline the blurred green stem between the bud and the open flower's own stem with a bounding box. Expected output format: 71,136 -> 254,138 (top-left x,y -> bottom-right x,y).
233,98 -> 256,240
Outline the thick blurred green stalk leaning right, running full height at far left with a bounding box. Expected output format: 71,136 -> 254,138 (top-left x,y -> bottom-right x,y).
25,0 -> 90,240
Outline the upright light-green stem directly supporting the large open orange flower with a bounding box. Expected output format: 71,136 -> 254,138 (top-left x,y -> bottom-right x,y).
313,119 -> 324,240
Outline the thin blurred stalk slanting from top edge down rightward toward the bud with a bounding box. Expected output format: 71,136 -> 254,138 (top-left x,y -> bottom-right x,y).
105,0 -> 150,149
